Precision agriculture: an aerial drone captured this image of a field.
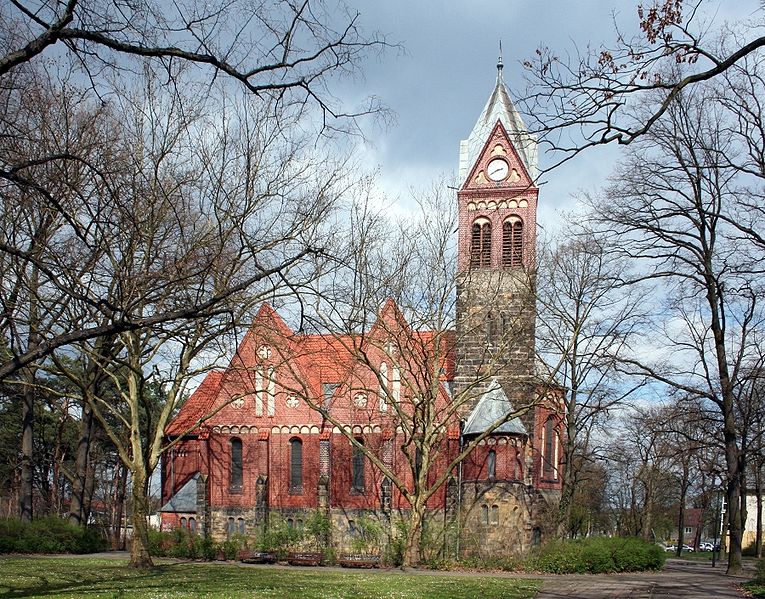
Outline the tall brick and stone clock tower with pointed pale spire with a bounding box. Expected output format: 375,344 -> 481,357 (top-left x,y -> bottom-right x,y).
455,57 -> 539,410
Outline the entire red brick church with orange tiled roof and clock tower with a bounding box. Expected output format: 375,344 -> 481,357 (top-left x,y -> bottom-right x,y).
162,62 -> 562,555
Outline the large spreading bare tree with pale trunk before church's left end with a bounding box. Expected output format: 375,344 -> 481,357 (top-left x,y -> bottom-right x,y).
15,65 -> 356,567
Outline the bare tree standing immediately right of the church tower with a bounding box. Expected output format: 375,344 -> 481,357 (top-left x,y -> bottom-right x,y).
537,230 -> 645,536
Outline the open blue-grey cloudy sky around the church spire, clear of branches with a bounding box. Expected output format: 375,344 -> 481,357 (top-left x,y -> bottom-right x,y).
339,0 -> 760,229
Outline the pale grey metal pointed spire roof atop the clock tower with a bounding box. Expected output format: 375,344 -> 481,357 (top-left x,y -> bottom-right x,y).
459,59 -> 539,183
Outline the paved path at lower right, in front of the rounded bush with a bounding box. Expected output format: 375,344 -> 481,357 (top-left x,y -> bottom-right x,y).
536,560 -> 753,599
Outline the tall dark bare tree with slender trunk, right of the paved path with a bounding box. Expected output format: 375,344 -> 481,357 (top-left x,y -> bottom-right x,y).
594,82 -> 762,573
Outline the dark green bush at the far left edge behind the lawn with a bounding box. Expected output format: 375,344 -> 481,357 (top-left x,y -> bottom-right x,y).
0,516 -> 106,553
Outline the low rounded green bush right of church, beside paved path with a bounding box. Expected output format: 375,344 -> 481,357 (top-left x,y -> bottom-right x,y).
525,537 -> 666,574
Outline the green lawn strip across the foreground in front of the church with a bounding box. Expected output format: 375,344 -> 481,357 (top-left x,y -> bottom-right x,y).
0,556 -> 541,599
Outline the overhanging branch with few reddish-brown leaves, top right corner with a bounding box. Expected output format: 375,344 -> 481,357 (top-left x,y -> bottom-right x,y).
519,0 -> 765,169
